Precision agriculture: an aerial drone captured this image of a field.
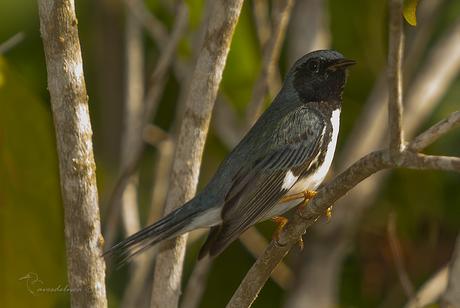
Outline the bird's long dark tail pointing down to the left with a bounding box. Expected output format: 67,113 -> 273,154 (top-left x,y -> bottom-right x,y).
103,199 -> 202,265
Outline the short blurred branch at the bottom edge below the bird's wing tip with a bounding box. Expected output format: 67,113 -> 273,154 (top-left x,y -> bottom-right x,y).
181,258 -> 212,308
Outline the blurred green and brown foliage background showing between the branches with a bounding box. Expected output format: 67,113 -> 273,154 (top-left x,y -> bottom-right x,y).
0,0 -> 460,307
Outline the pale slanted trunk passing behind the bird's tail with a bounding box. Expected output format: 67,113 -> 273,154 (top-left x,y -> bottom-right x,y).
152,0 -> 243,307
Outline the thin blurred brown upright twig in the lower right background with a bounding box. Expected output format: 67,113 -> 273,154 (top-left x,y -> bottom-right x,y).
387,213 -> 416,300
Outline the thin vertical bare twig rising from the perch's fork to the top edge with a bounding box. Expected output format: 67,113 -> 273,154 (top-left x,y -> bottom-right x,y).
388,0 -> 404,159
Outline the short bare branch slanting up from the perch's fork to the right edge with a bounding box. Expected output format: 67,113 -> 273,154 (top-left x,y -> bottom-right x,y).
408,111 -> 460,152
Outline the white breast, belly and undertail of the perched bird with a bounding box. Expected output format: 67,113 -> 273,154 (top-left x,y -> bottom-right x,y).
265,109 -> 340,219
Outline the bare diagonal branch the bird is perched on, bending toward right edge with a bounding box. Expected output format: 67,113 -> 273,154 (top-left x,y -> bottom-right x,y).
227,110 -> 460,307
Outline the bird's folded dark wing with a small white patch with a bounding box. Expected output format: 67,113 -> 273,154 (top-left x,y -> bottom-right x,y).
200,107 -> 326,255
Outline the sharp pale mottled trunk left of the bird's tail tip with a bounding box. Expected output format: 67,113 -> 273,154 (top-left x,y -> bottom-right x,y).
38,0 -> 107,307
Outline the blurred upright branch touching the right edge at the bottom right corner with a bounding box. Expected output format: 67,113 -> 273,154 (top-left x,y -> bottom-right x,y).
441,236 -> 460,308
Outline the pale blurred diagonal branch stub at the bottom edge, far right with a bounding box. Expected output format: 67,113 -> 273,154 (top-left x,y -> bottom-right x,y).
405,266 -> 449,308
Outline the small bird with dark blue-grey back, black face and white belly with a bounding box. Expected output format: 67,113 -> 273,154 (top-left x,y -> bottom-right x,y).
104,50 -> 356,261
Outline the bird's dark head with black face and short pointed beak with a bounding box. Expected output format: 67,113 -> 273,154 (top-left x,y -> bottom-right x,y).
285,50 -> 356,102
